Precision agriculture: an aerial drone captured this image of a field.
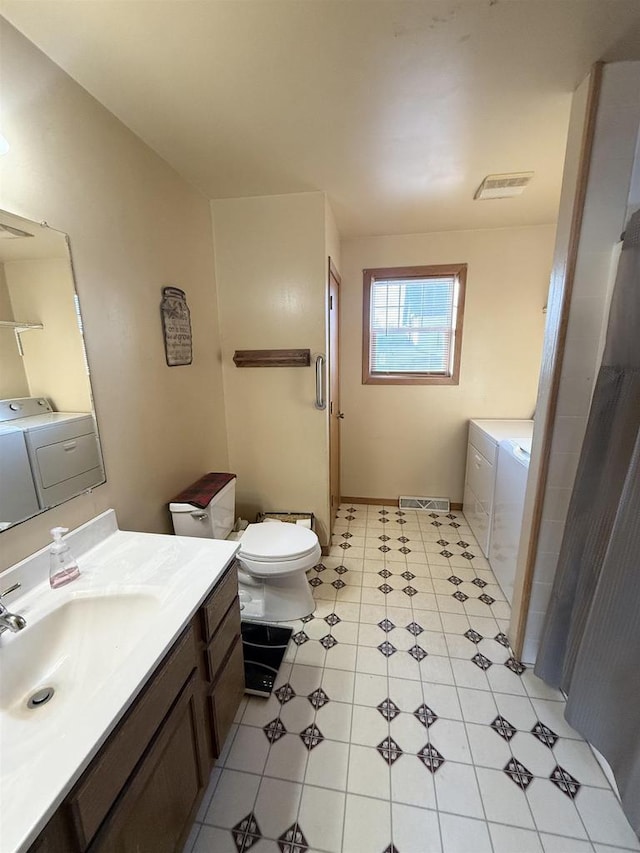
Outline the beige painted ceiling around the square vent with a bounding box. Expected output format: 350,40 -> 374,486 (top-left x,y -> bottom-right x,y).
0,0 -> 640,237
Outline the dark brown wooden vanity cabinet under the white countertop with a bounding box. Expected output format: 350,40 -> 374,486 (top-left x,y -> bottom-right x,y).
30,564 -> 244,853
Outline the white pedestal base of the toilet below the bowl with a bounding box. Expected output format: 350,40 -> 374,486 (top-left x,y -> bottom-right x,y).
238,571 -> 316,622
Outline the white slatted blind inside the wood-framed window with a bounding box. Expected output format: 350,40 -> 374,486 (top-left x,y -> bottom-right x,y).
369,275 -> 459,376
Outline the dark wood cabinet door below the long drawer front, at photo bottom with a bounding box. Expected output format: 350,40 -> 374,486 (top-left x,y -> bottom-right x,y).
90,673 -> 206,853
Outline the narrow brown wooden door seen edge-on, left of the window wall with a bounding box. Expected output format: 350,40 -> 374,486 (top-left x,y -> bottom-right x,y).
329,258 -> 344,532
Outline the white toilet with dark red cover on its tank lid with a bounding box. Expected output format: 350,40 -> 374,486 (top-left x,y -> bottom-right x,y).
169,474 -> 321,622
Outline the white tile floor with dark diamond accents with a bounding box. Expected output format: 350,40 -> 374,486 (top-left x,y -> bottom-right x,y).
185,505 -> 640,853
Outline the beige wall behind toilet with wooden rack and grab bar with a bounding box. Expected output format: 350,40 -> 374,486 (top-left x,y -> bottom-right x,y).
212,192 -> 329,543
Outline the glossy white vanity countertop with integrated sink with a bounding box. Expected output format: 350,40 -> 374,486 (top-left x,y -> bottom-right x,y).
0,513 -> 239,853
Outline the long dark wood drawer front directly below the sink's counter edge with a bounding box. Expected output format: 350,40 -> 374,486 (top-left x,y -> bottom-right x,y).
68,626 -> 197,850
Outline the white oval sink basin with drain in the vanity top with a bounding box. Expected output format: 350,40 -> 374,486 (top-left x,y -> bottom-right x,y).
0,593 -> 158,720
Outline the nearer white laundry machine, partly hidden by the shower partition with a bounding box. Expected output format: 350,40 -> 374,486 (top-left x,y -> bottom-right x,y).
489,438 -> 531,604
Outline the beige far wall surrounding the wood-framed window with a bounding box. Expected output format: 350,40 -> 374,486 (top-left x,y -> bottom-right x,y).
341,226 -> 554,502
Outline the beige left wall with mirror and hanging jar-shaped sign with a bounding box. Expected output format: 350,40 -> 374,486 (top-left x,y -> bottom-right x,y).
0,21 -> 228,566
